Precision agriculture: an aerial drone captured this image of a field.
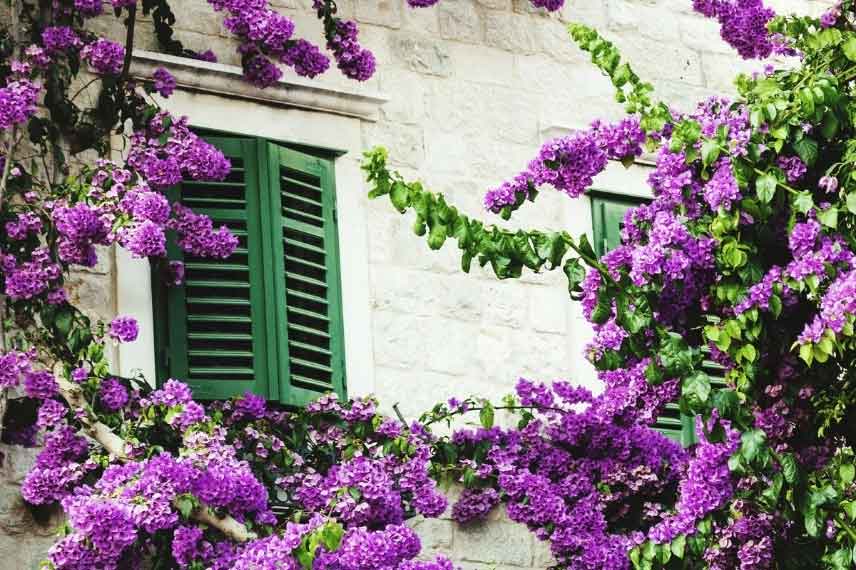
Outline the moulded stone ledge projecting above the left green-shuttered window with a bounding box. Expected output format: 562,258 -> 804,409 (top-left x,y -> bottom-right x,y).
131,50 -> 388,121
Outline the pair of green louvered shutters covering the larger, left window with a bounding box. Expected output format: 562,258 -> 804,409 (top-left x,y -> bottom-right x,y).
153,137 -> 345,406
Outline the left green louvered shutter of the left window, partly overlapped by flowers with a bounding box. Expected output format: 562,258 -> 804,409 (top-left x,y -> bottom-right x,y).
159,137 -> 270,399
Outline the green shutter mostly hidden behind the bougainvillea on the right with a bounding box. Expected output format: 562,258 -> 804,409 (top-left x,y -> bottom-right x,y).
591,194 -> 696,446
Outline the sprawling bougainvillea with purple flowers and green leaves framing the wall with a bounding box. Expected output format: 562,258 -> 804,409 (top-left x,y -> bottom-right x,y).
0,0 -> 856,570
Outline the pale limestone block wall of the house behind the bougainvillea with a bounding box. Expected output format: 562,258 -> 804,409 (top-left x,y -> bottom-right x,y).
0,0 -> 829,570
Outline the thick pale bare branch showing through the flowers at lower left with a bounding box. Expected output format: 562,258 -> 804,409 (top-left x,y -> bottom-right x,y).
54,365 -> 256,542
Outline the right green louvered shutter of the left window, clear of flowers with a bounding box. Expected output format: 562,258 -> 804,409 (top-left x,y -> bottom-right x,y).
263,144 -> 345,405
